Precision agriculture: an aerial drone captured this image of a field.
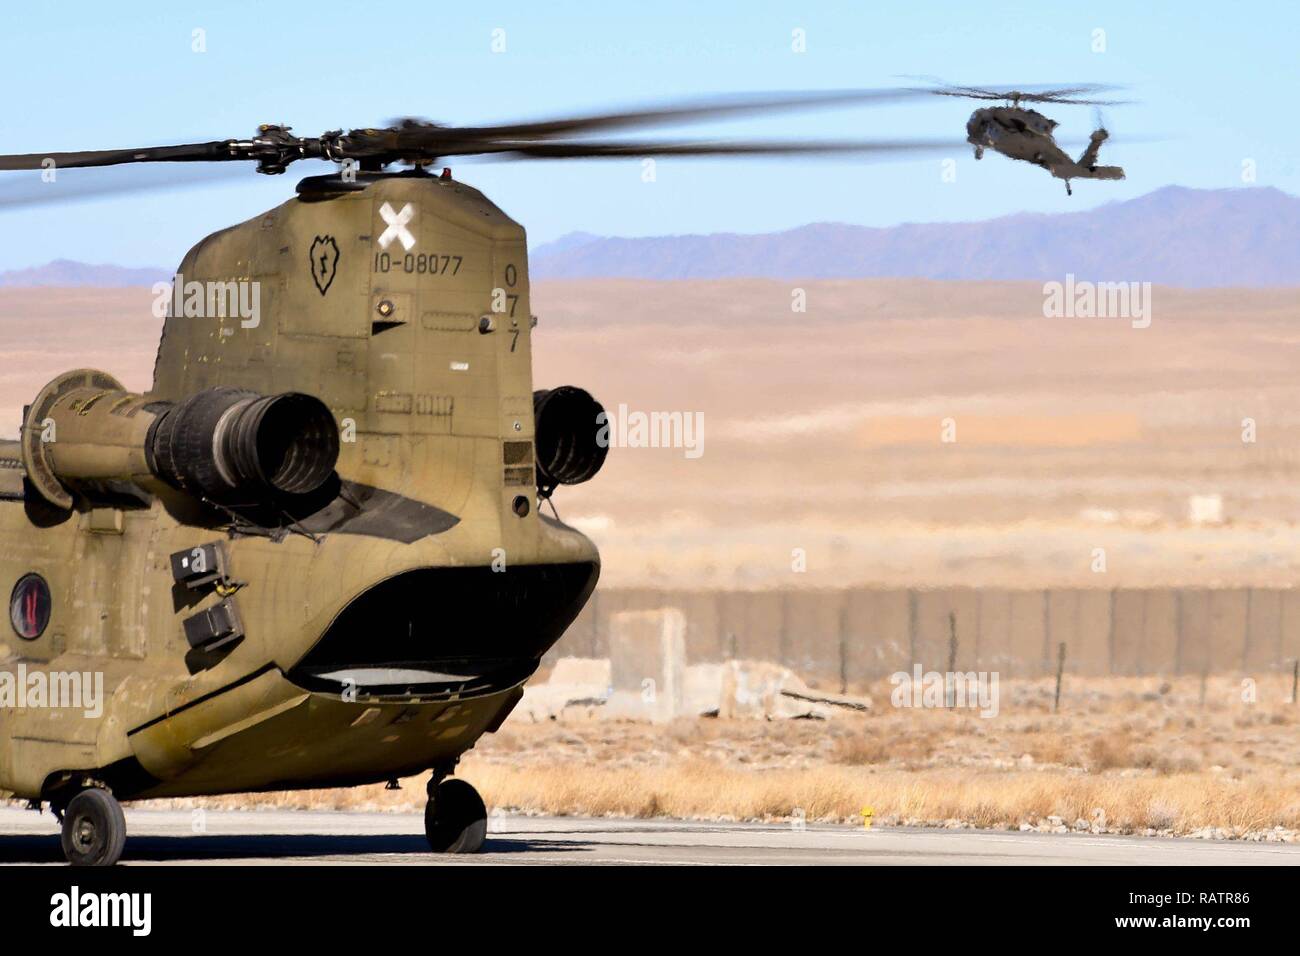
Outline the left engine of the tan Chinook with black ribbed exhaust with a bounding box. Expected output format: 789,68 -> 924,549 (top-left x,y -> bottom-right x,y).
22,369 -> 339,509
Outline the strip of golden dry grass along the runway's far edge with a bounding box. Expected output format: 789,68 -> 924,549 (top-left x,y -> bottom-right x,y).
159,760 -> 1300,836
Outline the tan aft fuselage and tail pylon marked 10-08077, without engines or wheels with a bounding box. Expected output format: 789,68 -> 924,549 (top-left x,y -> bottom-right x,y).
0,176 -> 599,799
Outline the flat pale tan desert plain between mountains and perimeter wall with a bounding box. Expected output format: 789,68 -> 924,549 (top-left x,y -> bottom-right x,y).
0,280 -> 1300,588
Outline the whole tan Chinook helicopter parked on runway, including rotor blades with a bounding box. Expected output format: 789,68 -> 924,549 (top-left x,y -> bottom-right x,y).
0,91 -> 982,865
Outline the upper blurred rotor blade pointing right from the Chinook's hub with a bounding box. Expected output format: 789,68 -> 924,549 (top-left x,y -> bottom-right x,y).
394,87 -> 941,139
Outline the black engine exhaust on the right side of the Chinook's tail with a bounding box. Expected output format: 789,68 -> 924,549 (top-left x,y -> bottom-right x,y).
533,385 -> 610,494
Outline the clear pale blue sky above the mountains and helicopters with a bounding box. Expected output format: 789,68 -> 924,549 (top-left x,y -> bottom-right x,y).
0,0 -> 1300,271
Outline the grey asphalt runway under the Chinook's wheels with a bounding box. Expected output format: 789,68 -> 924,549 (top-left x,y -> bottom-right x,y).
0,809 -> 1300,866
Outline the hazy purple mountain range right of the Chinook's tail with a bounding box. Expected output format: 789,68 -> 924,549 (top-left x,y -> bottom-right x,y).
530,186 -> 1300,287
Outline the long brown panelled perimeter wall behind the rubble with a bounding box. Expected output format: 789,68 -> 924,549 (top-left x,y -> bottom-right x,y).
547,588 -> 1300,685
